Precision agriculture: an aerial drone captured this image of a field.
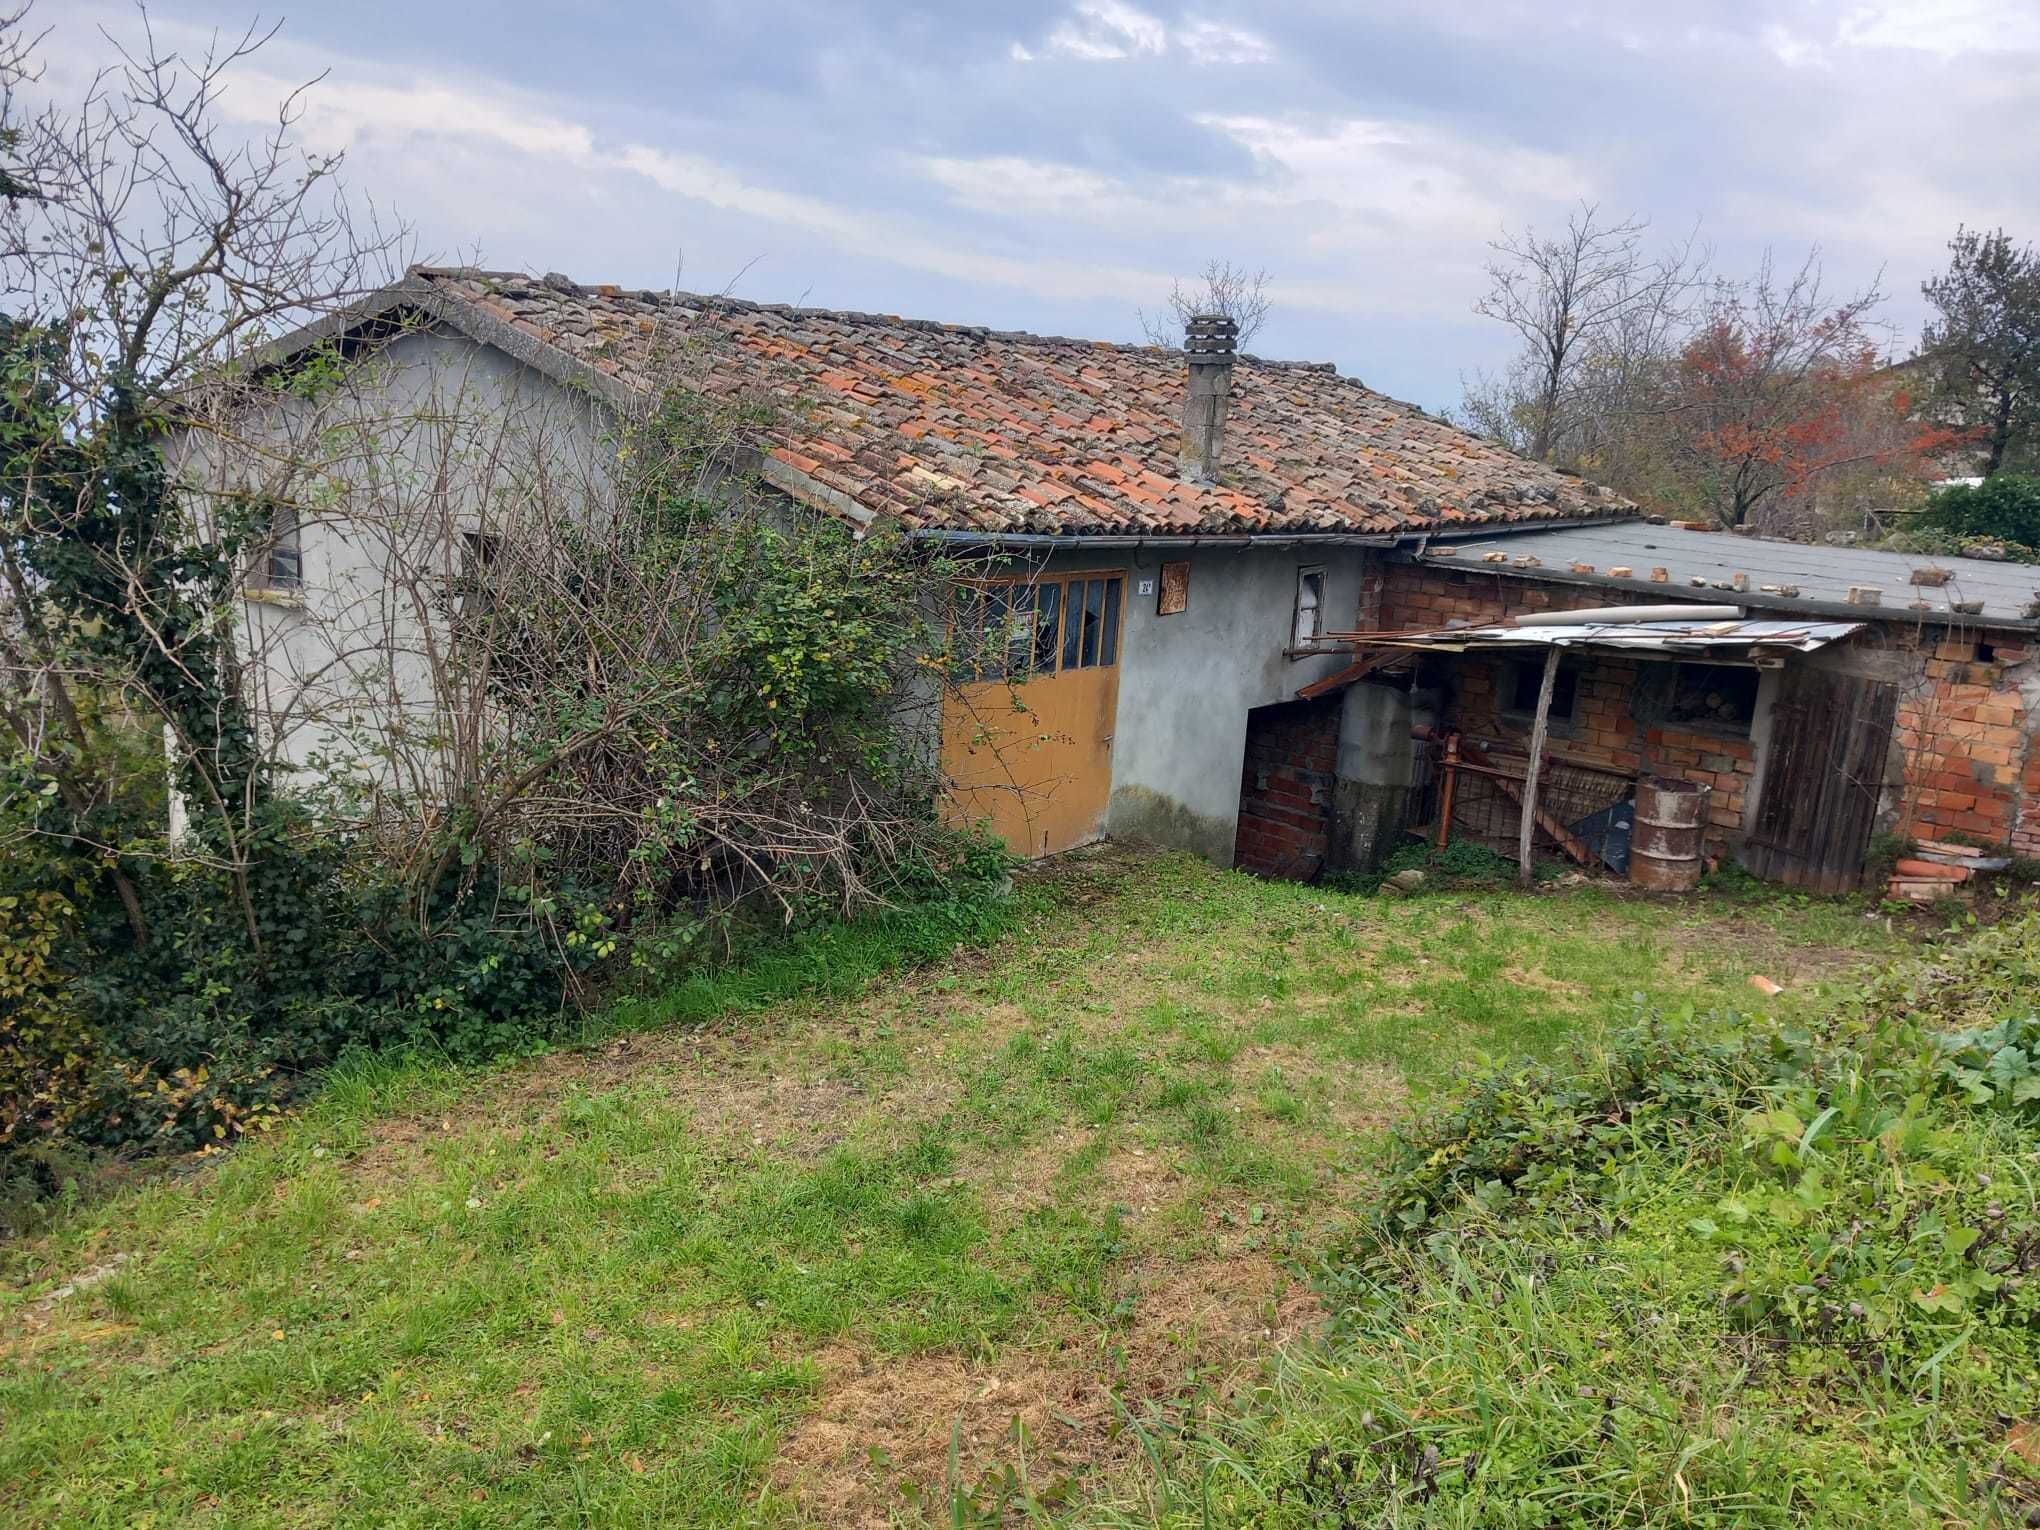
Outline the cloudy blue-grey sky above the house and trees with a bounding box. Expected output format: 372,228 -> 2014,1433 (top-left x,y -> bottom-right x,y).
39,0 -> 2040,408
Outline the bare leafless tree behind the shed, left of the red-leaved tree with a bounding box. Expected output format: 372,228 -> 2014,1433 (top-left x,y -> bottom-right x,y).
1465,202 -> 1707,461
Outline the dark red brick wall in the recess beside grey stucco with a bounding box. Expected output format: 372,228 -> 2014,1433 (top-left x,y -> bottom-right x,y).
1232,696 -> 1338,879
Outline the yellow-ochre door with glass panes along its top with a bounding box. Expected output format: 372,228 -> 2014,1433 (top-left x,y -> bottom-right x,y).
942,573 -> 1124,857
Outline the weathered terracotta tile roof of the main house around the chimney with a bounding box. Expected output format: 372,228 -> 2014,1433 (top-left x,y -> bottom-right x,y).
400,267 -> 1634,534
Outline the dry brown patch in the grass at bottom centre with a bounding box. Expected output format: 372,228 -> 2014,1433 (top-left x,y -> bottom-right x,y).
773,1255 -> 1324,1530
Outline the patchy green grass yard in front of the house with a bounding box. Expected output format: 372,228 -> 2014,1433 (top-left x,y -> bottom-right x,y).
0,853 -> 1907,1526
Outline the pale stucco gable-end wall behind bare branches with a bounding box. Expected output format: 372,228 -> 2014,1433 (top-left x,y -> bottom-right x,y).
180,330 -> 614,794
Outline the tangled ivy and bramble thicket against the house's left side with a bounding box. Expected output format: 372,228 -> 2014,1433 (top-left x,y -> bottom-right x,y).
0,346 -> 1004,1189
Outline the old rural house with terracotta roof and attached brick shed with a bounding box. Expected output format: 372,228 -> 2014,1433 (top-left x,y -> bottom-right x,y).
223,269 -> 2040,893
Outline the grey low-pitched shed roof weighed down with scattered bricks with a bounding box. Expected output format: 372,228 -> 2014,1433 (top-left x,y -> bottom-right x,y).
1420,520 -> 2040,630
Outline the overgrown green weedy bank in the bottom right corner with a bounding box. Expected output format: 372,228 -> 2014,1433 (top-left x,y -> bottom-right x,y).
1117,914 -> 2040,1530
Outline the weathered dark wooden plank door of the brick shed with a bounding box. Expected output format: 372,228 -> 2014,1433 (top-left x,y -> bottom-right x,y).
1742,665 -> 1899,891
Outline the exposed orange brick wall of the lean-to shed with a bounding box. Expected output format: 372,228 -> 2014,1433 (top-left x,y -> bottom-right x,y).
1381,563 -> 2040,855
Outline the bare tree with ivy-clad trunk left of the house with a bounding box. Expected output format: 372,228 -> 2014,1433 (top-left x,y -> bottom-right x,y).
0,10 -> 402,945
